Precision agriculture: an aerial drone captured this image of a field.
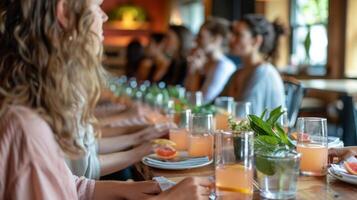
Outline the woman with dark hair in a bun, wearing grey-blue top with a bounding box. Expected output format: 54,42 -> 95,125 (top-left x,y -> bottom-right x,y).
222,14 -> 285,115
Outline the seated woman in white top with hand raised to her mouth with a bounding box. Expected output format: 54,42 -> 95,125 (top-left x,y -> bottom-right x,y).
185,18 -> 236,102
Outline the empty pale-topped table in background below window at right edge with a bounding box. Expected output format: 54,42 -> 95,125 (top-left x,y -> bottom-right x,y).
300,79 -> 357,146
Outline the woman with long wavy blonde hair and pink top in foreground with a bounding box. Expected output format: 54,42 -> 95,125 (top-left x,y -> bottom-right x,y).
0,0 -> 209,200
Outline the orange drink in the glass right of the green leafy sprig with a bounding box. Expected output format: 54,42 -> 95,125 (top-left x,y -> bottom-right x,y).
296,144 -> 328,176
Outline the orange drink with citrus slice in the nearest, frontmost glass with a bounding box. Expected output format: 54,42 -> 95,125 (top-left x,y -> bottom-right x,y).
216,164 -> 253,199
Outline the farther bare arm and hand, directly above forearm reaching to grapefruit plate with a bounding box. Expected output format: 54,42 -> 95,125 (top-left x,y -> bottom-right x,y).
98,124 -> 169,154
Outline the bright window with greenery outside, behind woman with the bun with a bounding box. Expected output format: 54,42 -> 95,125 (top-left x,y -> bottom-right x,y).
290,0 -> 328,75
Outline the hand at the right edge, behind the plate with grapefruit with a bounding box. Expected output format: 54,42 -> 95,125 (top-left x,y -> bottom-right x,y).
328,146 -> 357,163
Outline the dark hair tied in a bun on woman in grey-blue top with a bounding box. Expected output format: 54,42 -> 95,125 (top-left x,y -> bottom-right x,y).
241,14 -> 286,59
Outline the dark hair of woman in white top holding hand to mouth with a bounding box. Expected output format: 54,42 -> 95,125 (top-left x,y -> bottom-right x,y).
202,17 -> 230,39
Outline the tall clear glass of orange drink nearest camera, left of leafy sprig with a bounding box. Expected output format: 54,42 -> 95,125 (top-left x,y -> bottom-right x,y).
215,131 -> 254,200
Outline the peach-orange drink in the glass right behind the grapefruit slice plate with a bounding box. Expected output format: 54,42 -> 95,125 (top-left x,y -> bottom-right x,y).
188,134 -> 213,158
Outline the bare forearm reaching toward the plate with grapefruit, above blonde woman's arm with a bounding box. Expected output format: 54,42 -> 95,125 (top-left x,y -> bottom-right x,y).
99,143 -> 153,176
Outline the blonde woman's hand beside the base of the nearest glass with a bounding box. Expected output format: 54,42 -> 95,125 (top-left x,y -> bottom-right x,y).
152,177 -> 212,200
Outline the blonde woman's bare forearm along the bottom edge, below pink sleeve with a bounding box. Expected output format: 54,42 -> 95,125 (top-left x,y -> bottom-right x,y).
93,181 -> 161,200
